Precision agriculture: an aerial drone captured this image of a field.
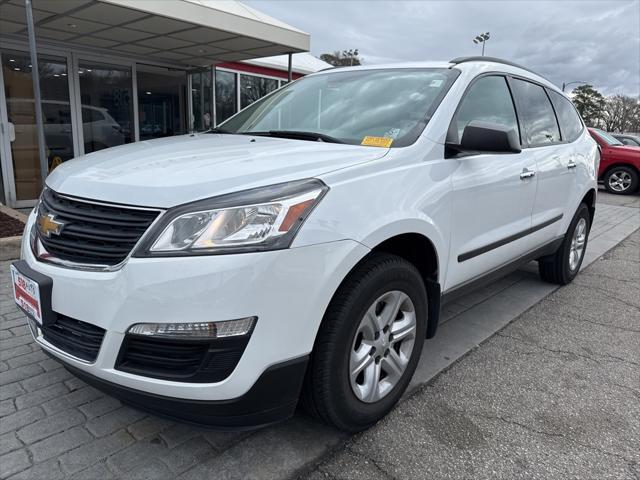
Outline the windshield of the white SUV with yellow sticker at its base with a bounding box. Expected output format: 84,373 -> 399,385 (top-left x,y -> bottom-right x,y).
218,68 -> 460,147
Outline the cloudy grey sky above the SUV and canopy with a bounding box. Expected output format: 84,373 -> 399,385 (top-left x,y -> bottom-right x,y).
244,0 -> 640,96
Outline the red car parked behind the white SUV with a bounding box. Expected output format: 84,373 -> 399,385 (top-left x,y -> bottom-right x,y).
589,128 -> 640,195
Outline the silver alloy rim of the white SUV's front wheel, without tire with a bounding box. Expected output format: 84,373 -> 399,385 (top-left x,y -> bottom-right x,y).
349,290 -> 416,403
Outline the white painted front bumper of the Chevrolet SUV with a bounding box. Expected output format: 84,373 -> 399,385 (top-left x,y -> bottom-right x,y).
22,215 -> 368,422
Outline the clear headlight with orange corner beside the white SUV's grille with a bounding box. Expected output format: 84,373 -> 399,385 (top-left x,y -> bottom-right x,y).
134,179 -> 328,257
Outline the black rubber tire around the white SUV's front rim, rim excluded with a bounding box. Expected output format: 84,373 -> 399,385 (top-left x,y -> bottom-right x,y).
301,253 -> 427,432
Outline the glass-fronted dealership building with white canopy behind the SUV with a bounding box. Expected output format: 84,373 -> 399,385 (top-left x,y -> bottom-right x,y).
0,0 -> 329,207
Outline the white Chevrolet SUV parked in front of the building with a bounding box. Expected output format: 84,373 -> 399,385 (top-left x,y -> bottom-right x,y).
12,57 -> 599,431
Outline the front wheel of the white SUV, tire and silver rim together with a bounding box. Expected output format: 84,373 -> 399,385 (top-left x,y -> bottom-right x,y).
302,253 -> 427,432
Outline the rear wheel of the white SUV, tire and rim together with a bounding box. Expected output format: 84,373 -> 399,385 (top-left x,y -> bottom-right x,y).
538,203 -> 591,285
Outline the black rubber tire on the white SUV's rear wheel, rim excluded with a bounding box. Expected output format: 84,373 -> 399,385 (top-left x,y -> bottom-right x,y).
538,203 -> 591,285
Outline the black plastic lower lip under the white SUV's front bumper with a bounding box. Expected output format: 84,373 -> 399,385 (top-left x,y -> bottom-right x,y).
45,350 -> 309,430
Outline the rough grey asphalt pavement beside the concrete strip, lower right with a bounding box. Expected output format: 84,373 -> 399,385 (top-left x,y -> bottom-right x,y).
305,231 -> 640,480
